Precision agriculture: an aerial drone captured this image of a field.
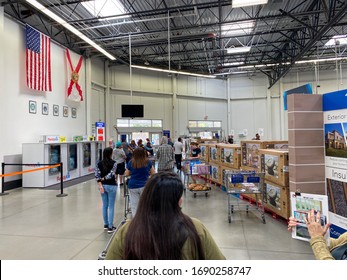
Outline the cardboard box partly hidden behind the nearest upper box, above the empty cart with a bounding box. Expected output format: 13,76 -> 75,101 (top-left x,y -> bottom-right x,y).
240,140 -> 288,172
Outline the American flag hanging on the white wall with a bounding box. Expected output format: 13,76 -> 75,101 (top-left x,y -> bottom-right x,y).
25,25 -> 52,91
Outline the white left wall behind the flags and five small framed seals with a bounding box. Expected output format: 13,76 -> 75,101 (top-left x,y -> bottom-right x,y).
0,17 -> 86,186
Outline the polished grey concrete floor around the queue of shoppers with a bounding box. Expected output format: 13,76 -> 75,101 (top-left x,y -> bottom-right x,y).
0,173 -> 314,260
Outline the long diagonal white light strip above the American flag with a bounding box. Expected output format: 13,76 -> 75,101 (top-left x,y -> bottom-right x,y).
26,0 -> 116,60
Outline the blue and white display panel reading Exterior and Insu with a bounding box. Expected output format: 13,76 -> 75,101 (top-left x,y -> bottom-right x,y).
323,90 -> 347,238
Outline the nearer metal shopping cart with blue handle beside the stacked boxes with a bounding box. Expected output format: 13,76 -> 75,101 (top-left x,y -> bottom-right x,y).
225,171 -> 265,224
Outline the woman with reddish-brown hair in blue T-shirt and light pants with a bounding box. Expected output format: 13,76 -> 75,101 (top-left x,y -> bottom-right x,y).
125,148 -> 155,217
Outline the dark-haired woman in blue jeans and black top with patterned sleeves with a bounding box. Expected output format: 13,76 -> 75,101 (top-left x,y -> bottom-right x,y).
95,147 -> 117,233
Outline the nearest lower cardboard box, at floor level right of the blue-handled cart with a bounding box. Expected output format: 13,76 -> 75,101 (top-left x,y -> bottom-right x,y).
264,180 -> 290,219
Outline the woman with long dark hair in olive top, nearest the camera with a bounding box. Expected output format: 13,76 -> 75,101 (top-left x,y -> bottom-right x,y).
106,172 -> 225,260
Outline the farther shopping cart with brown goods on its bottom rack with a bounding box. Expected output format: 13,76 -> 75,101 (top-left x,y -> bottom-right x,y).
183,159 -> 211,197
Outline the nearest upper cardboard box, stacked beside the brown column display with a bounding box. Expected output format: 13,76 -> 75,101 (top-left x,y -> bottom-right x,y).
259,149 -> 289,186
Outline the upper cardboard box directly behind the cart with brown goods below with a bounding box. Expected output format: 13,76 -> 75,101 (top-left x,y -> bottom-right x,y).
217,144 -> 241,169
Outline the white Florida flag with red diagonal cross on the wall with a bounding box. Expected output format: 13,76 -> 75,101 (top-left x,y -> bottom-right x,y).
66,49 -> 83,101
